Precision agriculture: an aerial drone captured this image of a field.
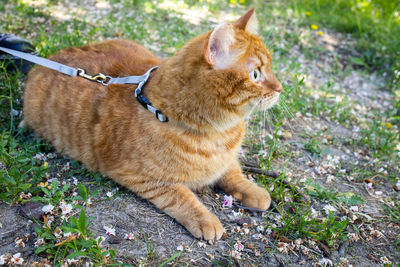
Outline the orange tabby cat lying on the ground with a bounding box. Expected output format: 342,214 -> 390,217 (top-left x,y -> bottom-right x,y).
24,9 -> 282,240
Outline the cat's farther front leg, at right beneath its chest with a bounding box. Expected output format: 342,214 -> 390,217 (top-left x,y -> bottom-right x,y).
218,163 -> 271,210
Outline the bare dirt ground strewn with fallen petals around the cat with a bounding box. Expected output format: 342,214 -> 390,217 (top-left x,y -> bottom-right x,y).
0,1 -> 400,266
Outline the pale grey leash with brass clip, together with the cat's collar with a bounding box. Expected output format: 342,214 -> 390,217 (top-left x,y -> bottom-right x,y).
0,46 -> 168,122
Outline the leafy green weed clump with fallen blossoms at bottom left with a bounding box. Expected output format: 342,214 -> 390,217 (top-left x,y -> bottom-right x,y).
35,183 -> 117,266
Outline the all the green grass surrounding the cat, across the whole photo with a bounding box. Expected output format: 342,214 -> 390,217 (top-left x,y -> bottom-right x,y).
0,0 -> 400,265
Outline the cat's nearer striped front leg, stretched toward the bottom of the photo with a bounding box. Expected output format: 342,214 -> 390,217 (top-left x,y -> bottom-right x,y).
123,180 -> 224,240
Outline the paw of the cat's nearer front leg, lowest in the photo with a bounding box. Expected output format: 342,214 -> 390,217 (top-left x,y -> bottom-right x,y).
184,212 -> 224,240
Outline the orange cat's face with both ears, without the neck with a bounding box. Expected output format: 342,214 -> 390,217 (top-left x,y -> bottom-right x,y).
204,8 -> 282,113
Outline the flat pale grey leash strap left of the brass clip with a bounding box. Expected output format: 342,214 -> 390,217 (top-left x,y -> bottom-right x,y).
0,47 -> 78,76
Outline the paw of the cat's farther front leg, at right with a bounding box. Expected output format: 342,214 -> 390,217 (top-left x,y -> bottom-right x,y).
233,184 -> 271,210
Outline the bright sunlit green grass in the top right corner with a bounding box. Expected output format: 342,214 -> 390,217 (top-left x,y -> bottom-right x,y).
291,0 -> 400,77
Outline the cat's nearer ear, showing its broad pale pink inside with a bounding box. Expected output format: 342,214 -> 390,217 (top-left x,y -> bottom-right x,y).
204,23 -> 235,69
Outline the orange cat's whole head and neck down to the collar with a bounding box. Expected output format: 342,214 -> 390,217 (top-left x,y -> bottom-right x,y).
151,9 -> 282,132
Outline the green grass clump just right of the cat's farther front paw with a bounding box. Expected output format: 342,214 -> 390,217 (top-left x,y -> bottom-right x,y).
264,173 -> 358,247
